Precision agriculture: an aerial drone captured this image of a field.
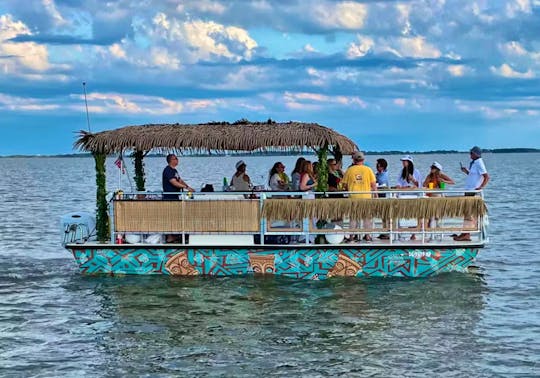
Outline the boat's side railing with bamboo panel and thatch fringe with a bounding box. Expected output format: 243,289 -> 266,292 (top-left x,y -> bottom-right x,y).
109,189 -> 487,245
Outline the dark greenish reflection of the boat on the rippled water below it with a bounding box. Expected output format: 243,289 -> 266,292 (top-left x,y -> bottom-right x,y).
72,274 -> 487,375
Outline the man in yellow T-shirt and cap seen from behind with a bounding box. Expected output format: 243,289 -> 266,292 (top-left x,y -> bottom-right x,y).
342,151 -> 377,241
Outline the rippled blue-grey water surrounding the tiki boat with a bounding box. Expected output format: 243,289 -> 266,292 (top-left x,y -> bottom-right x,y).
0,154 -> 540,377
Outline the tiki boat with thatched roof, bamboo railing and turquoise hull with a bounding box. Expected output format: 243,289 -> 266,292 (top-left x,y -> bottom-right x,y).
62,120 -> 487,279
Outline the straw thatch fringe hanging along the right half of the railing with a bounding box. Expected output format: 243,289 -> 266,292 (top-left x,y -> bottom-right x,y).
262,197 -> 487,221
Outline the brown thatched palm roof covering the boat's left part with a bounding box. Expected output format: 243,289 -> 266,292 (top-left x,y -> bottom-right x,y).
75,120 -> 358,154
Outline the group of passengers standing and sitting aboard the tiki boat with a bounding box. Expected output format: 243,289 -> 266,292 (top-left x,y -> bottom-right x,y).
162,146 -> 489,241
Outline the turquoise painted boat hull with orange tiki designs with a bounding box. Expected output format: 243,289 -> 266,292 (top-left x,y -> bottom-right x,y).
66,244 -> 479,280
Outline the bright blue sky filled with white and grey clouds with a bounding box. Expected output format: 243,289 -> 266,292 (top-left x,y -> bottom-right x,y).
0,0 -> 540,156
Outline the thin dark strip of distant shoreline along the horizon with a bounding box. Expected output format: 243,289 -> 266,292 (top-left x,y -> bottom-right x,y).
0,148 -> 540,158
